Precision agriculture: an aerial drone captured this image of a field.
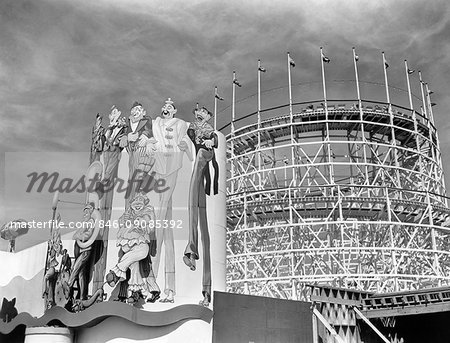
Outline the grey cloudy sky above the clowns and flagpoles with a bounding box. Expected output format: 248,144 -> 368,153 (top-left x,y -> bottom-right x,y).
0,0 -> 450,247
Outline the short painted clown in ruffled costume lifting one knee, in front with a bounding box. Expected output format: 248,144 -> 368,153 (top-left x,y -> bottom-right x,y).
106,193 -> 161,303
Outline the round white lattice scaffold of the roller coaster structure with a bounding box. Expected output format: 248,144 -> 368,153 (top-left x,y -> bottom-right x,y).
227,79 -> 450,299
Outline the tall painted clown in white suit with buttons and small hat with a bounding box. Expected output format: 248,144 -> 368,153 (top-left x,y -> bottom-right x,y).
152,98 -> 192,302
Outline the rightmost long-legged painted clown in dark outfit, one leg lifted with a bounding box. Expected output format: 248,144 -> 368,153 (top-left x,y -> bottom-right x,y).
183,107 -> 218,306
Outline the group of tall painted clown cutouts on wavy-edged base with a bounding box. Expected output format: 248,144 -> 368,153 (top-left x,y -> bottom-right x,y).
35,98 -> 225,318
